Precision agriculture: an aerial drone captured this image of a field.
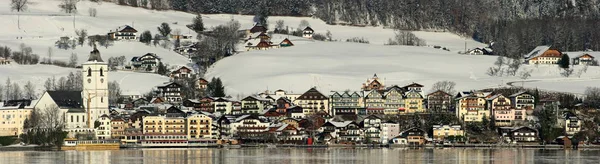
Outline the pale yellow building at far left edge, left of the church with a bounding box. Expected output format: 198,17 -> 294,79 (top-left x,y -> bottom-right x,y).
0,100 -> 35,136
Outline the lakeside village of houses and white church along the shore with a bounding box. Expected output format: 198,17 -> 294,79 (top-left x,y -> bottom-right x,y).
0,42 -> 598,150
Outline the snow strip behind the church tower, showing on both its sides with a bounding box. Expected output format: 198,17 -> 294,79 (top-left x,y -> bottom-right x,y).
0,64 -> 169,95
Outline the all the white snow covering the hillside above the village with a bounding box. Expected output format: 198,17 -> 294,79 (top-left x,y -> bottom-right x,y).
0,0 -> 600,96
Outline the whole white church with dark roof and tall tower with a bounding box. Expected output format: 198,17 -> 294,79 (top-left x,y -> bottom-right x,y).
34,47 -> 110,139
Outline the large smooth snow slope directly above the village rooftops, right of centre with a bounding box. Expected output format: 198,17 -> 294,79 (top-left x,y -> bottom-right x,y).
207,42 -> 600,95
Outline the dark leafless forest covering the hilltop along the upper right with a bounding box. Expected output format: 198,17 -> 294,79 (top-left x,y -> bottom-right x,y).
113,0 -> 600,57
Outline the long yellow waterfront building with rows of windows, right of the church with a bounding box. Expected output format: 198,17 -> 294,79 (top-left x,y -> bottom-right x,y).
142,116 -> 186,135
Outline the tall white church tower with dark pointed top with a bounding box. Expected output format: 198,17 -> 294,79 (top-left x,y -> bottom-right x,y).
81,46 -> 109,128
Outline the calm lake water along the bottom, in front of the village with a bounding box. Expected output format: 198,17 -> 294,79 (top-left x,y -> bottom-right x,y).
0,148 -> 600,164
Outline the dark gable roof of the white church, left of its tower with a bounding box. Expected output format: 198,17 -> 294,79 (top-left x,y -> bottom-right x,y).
47,91 -> 83,108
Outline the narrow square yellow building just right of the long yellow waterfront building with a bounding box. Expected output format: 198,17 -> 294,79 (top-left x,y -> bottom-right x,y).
186,114 -> 213,139
